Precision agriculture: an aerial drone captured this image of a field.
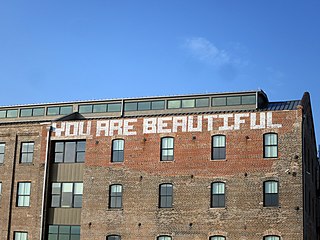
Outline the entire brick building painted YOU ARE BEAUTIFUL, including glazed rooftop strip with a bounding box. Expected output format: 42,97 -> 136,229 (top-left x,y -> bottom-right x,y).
0,90 -> 319,240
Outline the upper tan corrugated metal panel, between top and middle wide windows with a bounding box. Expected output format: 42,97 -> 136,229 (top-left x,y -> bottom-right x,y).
51,163 -> 84,182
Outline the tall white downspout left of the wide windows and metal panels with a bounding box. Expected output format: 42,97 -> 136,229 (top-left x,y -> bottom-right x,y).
39,126 -> 52,240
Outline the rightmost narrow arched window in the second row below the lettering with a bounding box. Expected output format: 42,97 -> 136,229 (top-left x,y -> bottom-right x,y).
263,181 -> 279,207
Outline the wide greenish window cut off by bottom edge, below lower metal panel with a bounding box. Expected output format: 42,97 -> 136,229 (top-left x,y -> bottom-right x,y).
48,225 -> 80,240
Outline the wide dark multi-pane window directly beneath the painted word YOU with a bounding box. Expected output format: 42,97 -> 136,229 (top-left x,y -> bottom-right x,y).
54,141 -> 86,163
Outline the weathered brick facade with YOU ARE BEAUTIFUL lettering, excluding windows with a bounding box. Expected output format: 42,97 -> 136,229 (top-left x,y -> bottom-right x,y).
0,90 -> 319,240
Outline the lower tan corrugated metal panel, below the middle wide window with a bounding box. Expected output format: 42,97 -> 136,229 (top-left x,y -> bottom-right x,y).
48,208 -> 81,225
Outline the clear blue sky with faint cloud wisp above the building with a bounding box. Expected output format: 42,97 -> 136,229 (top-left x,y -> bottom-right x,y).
0,0 -> 320,143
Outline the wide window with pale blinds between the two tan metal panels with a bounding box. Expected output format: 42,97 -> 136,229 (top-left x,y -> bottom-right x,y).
51,183 -> 83,208
